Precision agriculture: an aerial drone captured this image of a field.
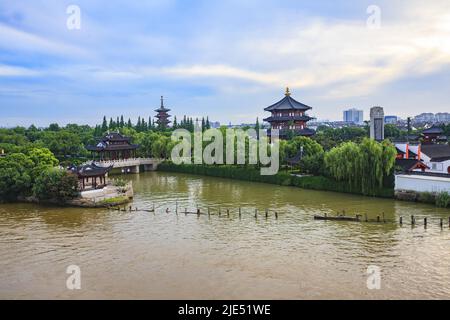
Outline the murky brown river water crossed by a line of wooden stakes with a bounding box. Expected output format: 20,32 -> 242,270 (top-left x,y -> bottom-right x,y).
0,172 -> 450,299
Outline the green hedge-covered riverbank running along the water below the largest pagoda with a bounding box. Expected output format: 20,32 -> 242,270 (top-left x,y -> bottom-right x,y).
158,162 -> 394,198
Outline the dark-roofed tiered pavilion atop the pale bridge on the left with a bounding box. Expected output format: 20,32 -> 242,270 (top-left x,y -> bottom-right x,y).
86,132 -> 139,161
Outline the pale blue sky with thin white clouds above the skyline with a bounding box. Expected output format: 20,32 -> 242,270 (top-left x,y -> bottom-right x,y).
0,0 -> 450,127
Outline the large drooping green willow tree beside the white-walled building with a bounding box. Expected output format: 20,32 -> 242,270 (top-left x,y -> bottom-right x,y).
325,138 -> 396,195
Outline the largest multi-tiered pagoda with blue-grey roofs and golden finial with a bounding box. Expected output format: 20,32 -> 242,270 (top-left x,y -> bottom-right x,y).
264,88 -> 316,139
